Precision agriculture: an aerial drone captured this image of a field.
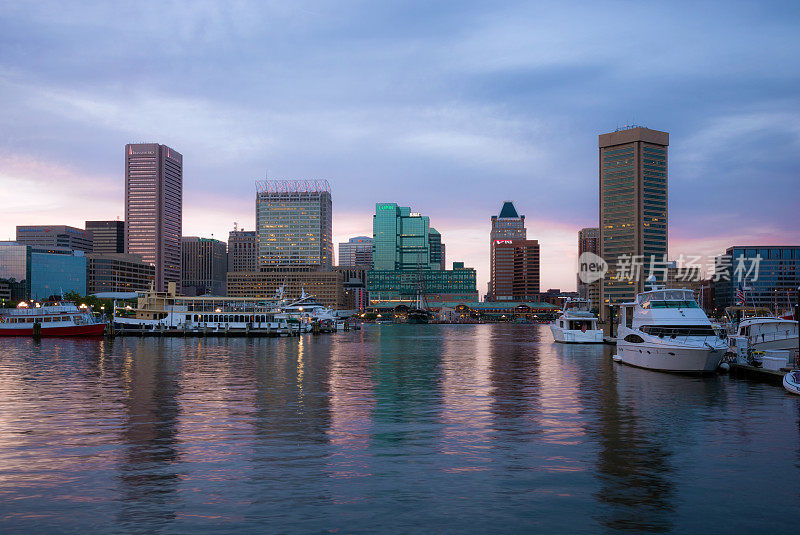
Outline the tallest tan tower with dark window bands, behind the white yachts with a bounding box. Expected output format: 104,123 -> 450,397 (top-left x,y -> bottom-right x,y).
598,126 -> 669,318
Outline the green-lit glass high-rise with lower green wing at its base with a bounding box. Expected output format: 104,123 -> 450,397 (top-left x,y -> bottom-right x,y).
367,203 -> 478,303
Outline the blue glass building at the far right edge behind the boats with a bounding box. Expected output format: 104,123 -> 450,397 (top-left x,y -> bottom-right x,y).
713,245 -> 800,315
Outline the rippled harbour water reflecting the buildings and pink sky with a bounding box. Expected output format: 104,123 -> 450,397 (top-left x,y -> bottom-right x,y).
0,325 -> 800,533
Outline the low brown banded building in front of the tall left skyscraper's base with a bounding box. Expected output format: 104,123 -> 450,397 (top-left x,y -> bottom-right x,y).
86,253 -> 156,294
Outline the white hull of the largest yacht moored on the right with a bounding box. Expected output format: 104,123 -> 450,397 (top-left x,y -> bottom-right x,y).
617,342 -> 725,373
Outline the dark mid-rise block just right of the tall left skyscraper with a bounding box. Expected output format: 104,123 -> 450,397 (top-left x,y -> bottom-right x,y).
181,236 -> 228,296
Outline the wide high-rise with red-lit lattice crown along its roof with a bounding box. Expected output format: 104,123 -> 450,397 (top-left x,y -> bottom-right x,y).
256,180 -> 333,271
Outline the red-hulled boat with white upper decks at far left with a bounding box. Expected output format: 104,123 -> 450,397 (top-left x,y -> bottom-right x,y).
0,301 -> 106,336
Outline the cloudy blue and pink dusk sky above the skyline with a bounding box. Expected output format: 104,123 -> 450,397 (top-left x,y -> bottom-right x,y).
0,0 -> 800,294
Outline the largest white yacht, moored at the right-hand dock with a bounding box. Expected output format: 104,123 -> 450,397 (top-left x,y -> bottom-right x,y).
614,284 -> 728,373
